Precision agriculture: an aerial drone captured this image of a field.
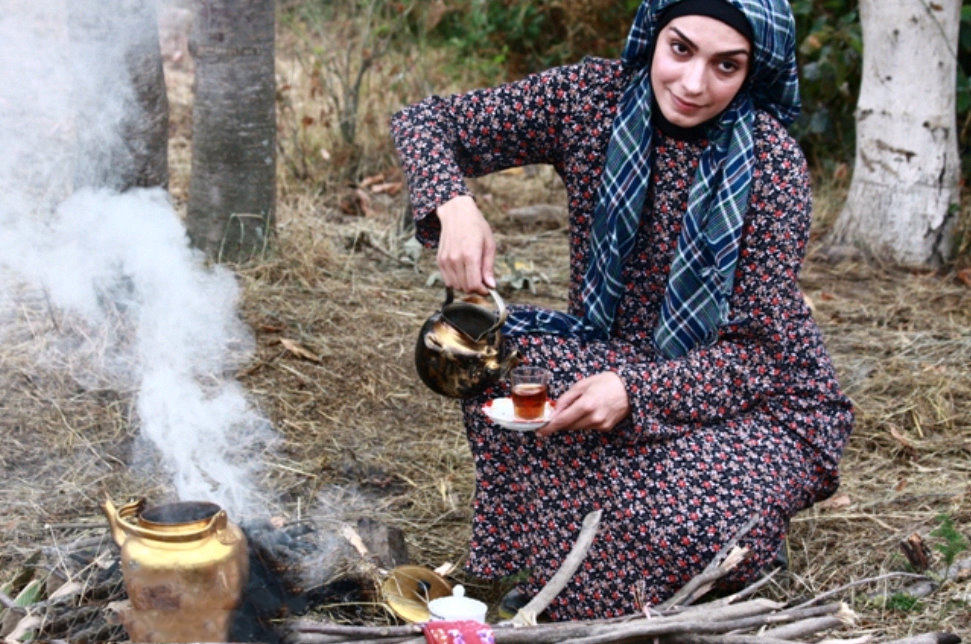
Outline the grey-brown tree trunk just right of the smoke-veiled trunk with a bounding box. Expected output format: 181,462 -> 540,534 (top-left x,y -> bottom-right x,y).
186,0 -> 276,261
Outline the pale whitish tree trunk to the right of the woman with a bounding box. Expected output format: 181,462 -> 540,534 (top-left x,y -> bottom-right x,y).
830,0 -> 961,266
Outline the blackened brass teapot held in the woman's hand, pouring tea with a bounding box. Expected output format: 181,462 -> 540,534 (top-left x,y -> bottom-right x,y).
415,288 -> 519,398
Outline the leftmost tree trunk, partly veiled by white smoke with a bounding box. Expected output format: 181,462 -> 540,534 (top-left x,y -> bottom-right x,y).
69,0 -> 169,191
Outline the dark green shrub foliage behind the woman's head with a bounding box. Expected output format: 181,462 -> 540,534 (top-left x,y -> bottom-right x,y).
422,0 -> 971,176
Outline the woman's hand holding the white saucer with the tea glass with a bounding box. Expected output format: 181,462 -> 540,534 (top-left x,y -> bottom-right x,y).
536,371 -> 630,436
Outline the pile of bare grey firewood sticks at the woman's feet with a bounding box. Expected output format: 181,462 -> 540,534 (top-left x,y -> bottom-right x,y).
286,511 -> 961,644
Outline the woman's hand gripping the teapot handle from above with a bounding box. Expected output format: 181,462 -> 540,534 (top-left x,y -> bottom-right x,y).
435,195 -> 496,294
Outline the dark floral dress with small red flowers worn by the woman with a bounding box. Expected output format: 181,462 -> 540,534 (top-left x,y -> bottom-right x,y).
392,59 -> 853,619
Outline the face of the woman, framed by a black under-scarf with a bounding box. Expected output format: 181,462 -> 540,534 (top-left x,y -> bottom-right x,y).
651,16 -> 751,127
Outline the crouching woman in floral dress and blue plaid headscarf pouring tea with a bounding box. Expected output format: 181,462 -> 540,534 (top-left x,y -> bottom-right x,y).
392,0 -> 853,619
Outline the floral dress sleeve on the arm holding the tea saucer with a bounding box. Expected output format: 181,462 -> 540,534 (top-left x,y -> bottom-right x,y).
616,127 -> 821,437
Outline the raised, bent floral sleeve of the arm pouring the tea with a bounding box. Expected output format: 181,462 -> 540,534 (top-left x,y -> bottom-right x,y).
391,63 -> 612,244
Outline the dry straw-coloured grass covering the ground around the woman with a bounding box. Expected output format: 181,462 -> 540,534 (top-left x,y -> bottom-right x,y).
0,7 -> 971,637
